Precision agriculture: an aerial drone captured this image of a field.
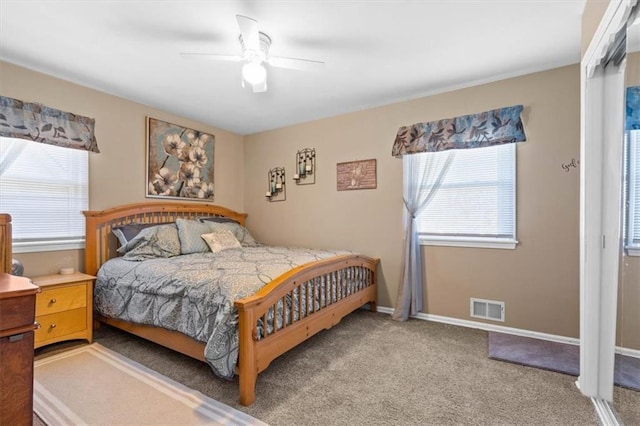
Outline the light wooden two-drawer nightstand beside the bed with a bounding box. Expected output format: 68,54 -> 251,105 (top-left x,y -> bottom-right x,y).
31,272 -> 96,348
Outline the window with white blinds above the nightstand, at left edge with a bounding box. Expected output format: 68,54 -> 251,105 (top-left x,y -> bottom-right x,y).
0,137 -> 89,253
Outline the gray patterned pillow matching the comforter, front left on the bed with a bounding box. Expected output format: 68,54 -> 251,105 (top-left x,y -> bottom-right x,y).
118,224 -> 180,261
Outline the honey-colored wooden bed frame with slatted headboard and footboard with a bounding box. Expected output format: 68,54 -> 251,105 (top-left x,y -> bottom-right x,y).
84,202 -> 379,406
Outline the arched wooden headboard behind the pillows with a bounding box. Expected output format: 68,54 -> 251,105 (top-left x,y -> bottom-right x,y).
83,202 -> 247,275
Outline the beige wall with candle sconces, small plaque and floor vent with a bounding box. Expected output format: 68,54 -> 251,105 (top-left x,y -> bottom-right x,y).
244,65 -> 580,337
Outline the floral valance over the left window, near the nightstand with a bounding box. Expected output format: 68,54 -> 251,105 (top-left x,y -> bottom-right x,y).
0,96 -> 100,152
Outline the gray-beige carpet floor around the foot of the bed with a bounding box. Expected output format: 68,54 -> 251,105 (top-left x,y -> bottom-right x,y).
38,310 -> 640,426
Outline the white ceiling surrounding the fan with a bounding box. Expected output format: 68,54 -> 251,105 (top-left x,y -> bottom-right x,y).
0,0 -> 585,134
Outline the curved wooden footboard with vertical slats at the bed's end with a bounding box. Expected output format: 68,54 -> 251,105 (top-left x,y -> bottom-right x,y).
235,255 -> 378,405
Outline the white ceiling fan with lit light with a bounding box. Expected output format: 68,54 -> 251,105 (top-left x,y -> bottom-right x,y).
181,15 -> 324,93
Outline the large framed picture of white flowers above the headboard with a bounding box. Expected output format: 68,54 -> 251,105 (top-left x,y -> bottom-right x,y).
147,117 -> 215,201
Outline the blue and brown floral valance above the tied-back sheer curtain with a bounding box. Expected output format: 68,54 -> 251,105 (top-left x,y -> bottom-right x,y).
392,105 -> 527,157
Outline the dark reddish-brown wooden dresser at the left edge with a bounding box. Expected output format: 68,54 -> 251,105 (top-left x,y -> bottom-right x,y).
0,273 -> 39,425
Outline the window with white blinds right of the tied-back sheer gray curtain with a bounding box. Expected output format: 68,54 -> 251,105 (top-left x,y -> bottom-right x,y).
418,144 -> 517,248
